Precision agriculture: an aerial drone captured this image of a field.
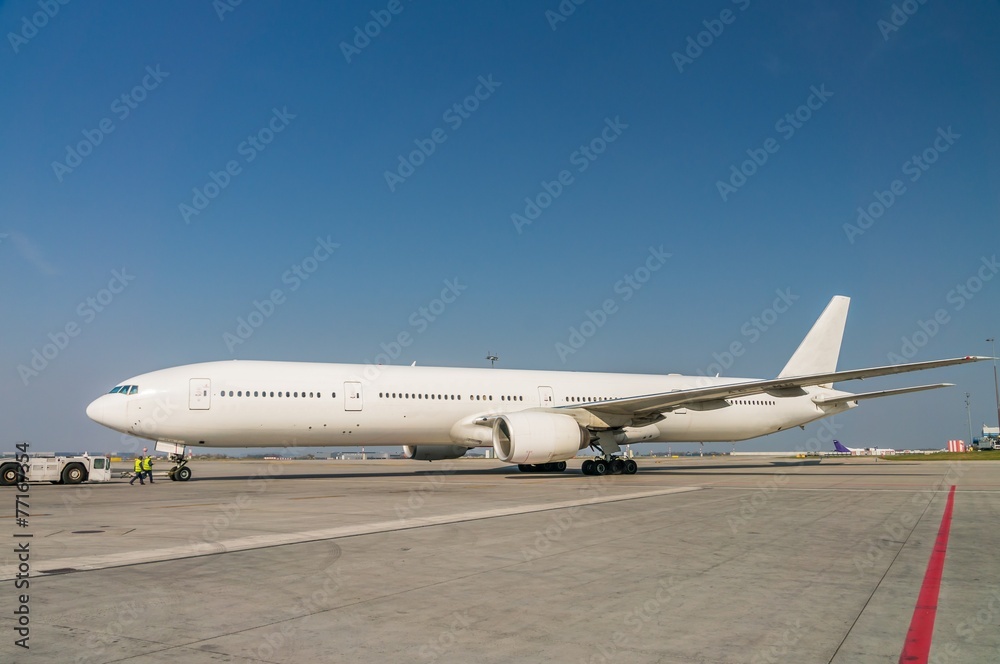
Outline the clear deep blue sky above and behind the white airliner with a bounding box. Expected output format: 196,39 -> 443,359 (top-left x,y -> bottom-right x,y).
0,0 -> 1000,451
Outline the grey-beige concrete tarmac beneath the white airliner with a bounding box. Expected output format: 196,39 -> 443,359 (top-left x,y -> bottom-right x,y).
0,457 -> 1000,664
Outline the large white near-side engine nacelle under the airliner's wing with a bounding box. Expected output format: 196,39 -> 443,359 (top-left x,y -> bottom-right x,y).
493,412 -> 590,464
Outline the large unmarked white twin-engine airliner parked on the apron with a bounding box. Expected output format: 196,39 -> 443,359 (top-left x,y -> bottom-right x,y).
87,296 -> 989,481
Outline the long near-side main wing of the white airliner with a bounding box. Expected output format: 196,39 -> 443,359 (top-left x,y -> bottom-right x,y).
576,356 -> 992,415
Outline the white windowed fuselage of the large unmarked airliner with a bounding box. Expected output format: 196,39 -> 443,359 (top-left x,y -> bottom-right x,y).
87,361 -> 854,447
